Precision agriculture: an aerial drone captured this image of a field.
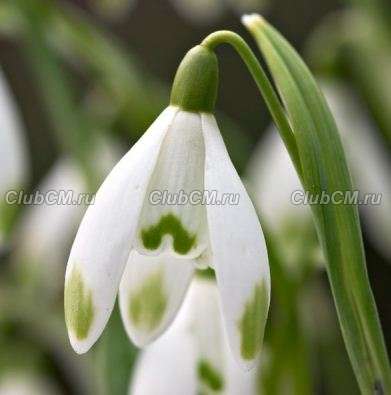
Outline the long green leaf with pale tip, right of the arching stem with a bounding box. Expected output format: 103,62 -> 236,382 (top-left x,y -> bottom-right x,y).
244,16 -> 391,394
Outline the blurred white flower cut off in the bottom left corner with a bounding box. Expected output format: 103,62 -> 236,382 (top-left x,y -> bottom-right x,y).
0,371 -> 61,395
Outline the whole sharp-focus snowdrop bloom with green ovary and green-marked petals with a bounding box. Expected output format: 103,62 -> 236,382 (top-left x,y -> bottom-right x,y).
65,46 -> 270,368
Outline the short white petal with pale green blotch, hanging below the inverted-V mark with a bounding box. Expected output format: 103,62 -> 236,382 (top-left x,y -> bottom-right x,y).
119,251 -> 194,347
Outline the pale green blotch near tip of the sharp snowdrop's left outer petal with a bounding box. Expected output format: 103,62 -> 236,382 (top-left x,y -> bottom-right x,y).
64,267 -> 94,340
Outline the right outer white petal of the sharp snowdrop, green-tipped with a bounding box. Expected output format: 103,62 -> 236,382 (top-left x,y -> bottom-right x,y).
202,114 -> 270,369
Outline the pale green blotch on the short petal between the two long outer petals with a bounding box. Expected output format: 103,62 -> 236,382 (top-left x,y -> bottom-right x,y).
129,271 -> 168,332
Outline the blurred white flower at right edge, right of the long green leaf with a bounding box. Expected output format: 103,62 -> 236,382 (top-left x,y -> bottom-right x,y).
322,83 -> 391,258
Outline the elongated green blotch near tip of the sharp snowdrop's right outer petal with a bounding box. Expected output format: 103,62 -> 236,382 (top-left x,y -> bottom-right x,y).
239,281 -> 269,360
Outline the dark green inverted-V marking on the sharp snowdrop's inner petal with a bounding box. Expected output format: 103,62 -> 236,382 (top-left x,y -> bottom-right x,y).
141,213 -> 196,255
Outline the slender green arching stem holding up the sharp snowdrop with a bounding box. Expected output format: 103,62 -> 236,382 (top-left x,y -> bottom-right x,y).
201,30 -> 302,177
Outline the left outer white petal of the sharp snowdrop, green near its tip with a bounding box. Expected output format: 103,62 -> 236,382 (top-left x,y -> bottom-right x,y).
65,107 -> 177,353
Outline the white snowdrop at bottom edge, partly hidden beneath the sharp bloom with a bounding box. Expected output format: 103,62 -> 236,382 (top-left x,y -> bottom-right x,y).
129,278 -> 259,395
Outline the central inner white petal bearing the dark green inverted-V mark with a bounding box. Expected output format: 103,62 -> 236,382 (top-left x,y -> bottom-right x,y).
136,111 -> 208,258
